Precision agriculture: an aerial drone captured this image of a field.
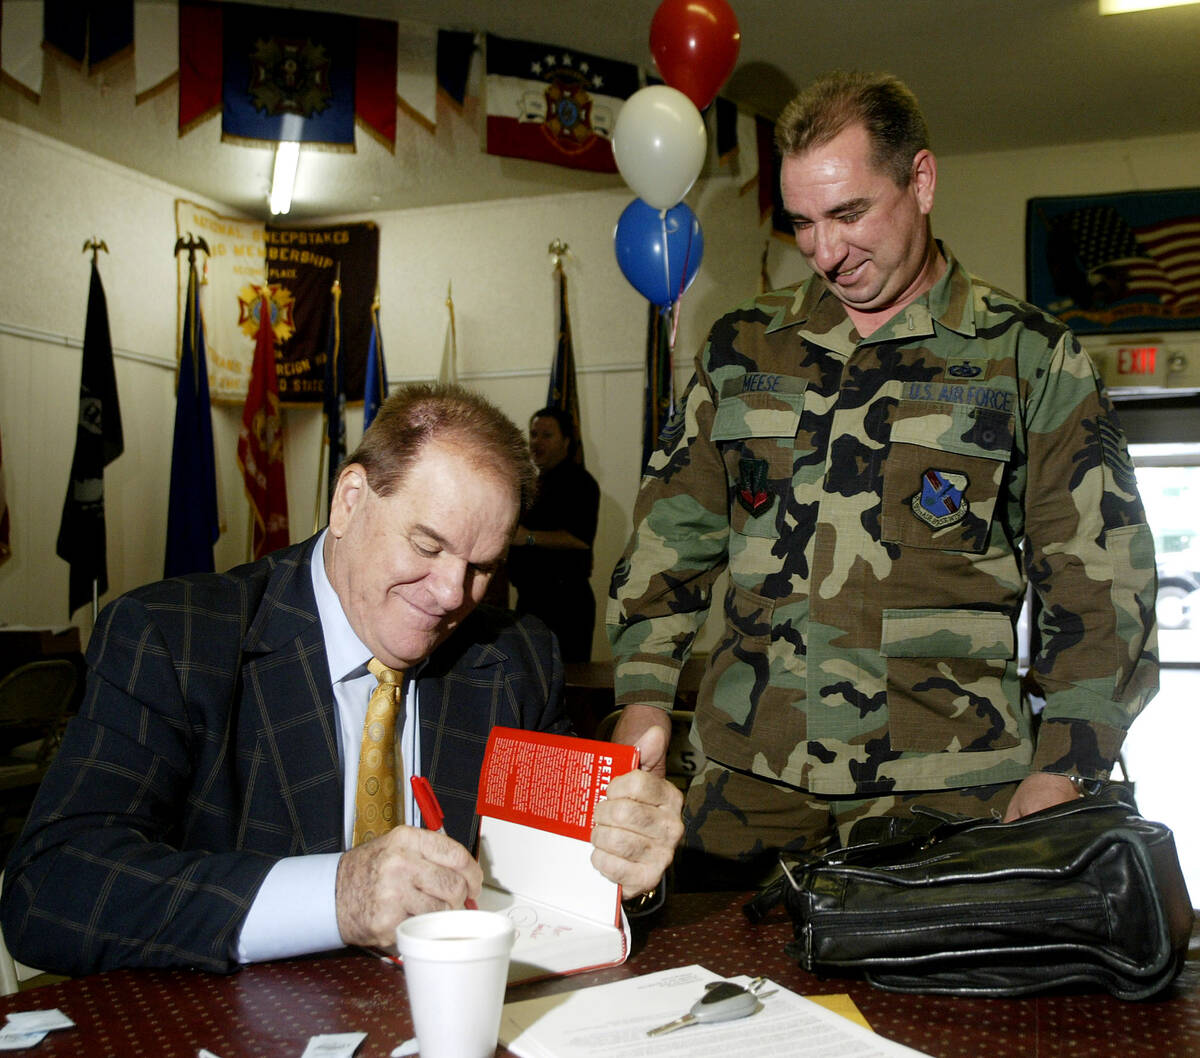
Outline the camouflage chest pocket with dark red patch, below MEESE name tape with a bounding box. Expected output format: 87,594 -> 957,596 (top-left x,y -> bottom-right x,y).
712,375 -> 805,536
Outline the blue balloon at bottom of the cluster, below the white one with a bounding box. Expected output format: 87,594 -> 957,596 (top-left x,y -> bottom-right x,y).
613,198 -> 704,306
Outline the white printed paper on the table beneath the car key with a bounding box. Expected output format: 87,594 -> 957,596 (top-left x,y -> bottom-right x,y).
500,966 -> 922,1058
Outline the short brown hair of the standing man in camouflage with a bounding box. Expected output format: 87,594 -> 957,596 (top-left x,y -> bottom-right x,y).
775,70 -> 929,187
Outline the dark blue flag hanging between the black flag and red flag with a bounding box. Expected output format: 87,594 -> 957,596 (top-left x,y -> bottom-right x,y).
163,260 -> 221,577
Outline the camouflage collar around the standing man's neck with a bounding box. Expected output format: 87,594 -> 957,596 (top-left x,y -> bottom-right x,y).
766,241 -> 976,355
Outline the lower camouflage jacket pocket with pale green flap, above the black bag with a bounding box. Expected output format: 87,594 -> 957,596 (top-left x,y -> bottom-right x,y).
880,608 -> 1028,753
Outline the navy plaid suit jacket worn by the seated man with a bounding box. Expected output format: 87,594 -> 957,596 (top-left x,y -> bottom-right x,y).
0,539 -> 568,975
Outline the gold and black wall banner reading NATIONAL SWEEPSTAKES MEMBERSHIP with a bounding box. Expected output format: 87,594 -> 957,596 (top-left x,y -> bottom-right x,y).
175,199 -> 379,404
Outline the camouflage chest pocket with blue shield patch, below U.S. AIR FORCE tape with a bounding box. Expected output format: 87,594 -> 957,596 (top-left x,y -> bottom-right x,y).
882,401 -> 1014,554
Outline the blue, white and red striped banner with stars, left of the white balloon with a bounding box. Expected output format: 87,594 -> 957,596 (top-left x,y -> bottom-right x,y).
486,34 -> 640,173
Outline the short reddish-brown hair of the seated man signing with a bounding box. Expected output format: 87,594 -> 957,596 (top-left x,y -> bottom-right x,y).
342,384 -> 538,511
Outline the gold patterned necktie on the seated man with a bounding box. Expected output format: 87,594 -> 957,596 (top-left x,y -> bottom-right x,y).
353,657 -> 404,844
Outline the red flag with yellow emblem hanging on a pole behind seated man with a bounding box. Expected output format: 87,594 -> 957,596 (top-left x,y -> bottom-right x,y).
238,289 -> 289,559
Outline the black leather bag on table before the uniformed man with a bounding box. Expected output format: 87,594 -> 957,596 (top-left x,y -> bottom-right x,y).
748,786 -> 1193,999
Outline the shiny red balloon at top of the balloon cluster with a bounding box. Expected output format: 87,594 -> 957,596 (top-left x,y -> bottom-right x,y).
650,0 -> 742,110
